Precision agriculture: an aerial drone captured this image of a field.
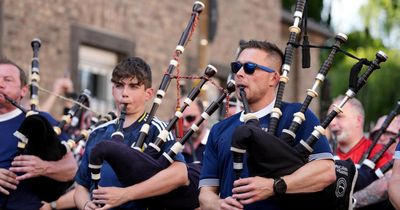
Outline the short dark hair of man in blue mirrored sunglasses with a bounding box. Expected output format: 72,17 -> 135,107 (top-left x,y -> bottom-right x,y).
238,40 -> 283,73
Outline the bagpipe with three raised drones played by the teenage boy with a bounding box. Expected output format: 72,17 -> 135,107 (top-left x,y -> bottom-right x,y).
89,1 -> 214,209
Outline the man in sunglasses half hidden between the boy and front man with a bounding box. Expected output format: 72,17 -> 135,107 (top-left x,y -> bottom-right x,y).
182,100 -> 210,163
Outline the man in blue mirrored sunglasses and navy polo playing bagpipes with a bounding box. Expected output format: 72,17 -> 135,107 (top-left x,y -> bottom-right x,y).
199,40 -> 335,210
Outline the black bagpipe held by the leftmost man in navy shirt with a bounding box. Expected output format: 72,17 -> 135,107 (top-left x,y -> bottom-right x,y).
3,38 -> 101,204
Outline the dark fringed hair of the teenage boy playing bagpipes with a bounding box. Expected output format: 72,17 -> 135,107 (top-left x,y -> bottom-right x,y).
111,57 -> 152,88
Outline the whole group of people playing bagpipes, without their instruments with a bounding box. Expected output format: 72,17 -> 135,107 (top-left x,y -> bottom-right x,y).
0,40 -> 400,210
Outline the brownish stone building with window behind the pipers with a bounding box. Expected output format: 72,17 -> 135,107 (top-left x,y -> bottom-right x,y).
0,0 -> 333,120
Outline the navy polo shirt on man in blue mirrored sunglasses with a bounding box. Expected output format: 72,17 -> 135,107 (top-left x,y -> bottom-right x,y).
199,103 -> 333,209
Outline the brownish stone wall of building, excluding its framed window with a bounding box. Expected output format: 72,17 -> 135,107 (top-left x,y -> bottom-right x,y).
0,0 -> 330,119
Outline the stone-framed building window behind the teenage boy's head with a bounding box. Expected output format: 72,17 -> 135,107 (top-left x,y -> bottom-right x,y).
70,24 -> 135,114
